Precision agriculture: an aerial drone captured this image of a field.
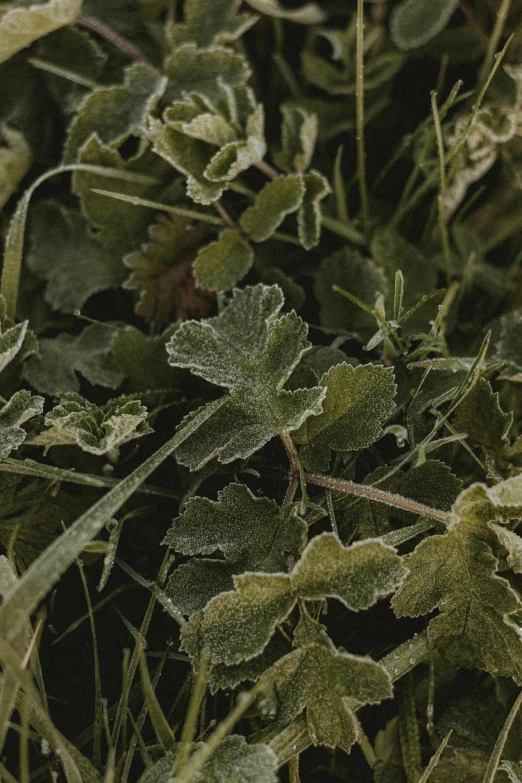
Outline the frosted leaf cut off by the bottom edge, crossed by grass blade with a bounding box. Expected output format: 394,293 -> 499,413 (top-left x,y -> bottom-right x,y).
140,734 -> 278,783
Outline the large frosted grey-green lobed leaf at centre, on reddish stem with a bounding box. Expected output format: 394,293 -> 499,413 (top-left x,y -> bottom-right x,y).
167,285 -> 325,470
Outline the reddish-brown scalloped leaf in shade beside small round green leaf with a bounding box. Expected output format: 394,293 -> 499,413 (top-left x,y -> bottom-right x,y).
123,214 -> 211,326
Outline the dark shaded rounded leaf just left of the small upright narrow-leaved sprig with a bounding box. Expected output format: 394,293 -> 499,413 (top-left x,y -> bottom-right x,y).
315,248 -> 387,342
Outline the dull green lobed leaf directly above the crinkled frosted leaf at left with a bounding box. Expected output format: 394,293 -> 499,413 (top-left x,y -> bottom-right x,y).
23,324 -> 125,396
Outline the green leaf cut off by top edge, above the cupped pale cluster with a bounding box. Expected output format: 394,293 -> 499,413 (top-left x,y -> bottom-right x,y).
168,0 -> 258,49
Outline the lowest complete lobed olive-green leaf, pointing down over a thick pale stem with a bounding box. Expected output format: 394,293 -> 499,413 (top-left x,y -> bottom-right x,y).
259,615 -> 392,752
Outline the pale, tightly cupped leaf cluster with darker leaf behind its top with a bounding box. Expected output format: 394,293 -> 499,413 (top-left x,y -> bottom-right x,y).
149,44 -> 266,204
